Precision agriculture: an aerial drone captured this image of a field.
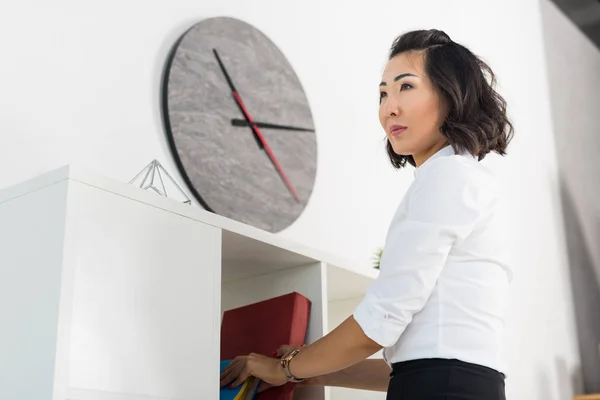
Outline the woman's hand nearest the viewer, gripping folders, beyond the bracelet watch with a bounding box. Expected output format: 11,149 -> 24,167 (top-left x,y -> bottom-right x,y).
221,346 -> 289,391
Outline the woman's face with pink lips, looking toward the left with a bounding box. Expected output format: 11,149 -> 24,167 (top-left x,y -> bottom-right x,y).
379,52 -> 447,166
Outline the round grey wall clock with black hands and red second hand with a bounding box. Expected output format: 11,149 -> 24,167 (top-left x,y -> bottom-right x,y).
162,17 -> 317,232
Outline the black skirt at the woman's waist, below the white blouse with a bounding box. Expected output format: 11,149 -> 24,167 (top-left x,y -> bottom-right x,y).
386,358 -> 506,400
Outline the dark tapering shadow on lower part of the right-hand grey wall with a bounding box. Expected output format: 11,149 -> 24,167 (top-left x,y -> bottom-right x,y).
560,176 -> 600,393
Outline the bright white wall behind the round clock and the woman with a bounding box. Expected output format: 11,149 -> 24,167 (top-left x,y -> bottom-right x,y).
0,0 -> 578,400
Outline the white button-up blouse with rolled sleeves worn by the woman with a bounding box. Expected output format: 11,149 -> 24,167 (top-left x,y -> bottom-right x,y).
354,146 -> 512,372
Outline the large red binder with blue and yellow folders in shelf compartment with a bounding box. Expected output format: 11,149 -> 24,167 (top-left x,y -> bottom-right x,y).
221,292 -> 311,400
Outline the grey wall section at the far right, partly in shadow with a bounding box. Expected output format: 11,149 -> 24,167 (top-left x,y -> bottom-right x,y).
542,0 -> 600,393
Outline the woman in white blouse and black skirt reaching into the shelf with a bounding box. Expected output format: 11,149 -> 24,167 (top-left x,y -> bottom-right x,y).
221,30 -> 513,400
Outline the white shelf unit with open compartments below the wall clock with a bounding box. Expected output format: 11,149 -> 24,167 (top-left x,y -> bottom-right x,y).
0,166 -> 384,400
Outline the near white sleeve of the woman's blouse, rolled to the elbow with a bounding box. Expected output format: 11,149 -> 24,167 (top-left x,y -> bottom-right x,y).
353,157 -> 494,347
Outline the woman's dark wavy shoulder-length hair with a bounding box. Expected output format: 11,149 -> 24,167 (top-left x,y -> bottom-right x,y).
386,29 -> 514,168
